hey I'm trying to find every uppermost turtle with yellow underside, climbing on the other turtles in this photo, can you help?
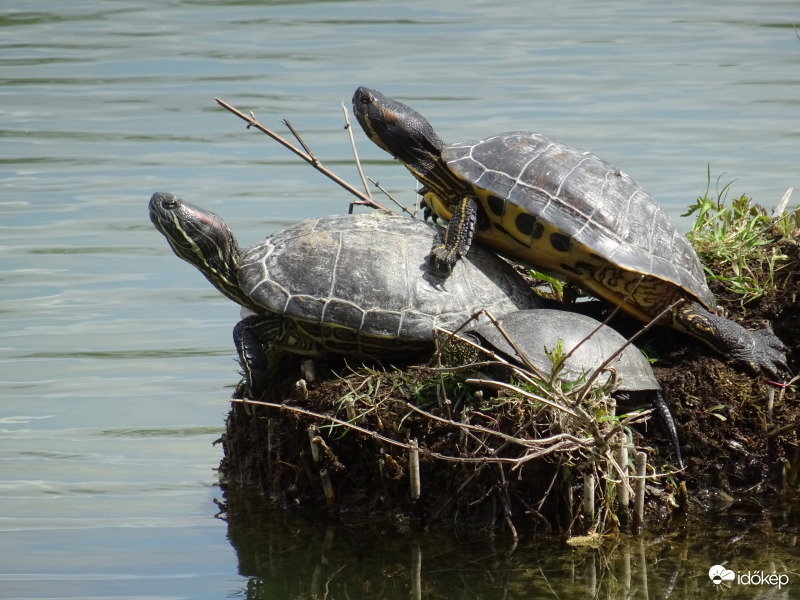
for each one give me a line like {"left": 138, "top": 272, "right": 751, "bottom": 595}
{"left": 353, "top": 87, "right": 786, "bottom": 378}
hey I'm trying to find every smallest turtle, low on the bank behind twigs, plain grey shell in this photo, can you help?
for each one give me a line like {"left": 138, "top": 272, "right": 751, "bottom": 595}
{"left": 461, "top": 308, "right": 683, "bottom": 469}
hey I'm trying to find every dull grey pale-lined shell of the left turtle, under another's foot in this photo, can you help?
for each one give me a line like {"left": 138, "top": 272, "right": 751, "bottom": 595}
{"left": 238, "top": 212, "right": 537, "bottom": 356}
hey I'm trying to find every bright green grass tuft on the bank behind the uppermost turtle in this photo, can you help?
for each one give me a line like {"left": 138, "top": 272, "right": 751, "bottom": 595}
{"left": 683, "top": 167, "right": 788, "bottom": 305}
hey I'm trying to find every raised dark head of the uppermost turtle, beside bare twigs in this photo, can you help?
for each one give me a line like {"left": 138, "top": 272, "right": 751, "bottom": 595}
{"left": 353, "top": 87, "right": 448, "bottom": 185}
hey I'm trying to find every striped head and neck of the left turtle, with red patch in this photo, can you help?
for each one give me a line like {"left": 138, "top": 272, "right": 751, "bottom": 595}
{"left": 150, "top": 192, "right": 251, "bottom": 306}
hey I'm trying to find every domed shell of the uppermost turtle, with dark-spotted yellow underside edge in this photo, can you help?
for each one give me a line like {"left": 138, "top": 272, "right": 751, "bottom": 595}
{"left": 442, "top": 131, "right": 715, "bottom": 309}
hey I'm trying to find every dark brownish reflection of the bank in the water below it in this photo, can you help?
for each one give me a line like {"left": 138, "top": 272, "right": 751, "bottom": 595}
{"left": 220, "top": 492, "right": 800, "bottom": 599}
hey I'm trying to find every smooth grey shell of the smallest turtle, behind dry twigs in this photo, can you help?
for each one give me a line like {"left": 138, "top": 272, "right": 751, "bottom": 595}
{"left": 466, "top": 308, "right": 661, "bottom": 392}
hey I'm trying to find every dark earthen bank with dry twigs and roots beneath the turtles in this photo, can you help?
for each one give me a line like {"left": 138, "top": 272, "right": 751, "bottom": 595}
{"left": 220, "top": 210, "right": 800, "bottom": 534}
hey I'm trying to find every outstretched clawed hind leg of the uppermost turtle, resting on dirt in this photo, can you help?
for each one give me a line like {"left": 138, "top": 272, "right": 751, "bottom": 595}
{"left": 672, "top": 302, "right": 787, "bottom": 378}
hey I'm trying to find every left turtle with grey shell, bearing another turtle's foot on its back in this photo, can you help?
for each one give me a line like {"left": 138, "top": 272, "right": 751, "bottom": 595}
{"left": 149, "top": 192, "right": 539, "bottom": 398}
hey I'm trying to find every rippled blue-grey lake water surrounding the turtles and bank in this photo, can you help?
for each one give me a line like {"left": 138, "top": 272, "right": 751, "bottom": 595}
{"left": 0, "top": 0, "right": 800, "bottom": 598}
